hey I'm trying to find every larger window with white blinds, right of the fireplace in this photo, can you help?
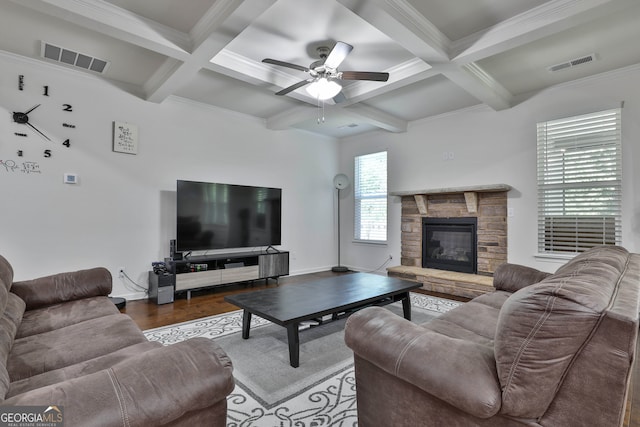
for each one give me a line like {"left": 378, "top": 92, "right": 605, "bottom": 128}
{"left": 538, "top": 109, "right": 622, "bottom": 253}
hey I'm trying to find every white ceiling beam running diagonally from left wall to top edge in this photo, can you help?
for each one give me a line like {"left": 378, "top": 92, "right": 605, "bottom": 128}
{"left": 144, "top": 0, "right": 275, "bottom": 102}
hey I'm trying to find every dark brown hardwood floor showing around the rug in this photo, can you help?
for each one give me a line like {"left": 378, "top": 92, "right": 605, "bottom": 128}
{"left": 121, "top": 271, "right": 640, "bottom": 427}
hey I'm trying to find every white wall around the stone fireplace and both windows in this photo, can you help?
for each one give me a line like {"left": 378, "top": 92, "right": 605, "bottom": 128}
{"left": 339, "top": 66, "right": 640, "bottom": 271}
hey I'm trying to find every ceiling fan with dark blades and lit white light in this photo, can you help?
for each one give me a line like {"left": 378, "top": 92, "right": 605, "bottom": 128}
{"left": 262, "top": 42, "right": 389, "bottom": 103}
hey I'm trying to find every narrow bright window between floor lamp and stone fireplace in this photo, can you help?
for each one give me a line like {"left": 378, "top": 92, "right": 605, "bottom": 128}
{"left": 354, "top": 151, "right": 387, "bottom": 242}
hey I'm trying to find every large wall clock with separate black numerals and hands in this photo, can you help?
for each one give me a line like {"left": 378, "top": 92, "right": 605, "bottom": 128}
{"left": 10, "top": 74, "right": 76, "bottom": 158}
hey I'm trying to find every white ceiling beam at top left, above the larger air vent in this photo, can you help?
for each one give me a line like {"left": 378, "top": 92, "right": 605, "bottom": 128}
{"left": 12, "top": 0, "right": 191, "bottom": 60}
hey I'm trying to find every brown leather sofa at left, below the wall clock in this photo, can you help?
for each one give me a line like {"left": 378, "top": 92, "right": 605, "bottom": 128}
{"left": 0, "top": 256, "right": 234, "bottom": 427}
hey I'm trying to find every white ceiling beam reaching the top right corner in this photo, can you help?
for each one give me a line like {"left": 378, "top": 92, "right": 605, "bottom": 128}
{"left": 451, "top": 0, "right": 637, "bottom": 64}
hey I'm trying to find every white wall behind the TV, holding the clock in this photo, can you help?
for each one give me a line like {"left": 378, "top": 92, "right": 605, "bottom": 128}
{"left": 0, "top": 56, "right": 338, "bottom": 298}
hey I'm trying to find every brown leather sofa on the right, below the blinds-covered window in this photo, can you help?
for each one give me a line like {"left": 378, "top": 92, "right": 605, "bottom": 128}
{"left": 345, "top": 246, "right": 640, "bottom": 427}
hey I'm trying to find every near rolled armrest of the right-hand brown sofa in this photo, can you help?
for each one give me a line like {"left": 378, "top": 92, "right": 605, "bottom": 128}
{"left": 345, "top": 307, "right": 501, "bottom": 418}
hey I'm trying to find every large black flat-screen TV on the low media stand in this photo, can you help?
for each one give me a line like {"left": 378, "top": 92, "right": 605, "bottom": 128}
{"left": 176, "top": 180, "right": 282, "bottom": 252}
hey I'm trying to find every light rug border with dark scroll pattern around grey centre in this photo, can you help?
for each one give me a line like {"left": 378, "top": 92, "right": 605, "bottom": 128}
{"left": 145, "top": 293, "right": 460, "bottom": 427}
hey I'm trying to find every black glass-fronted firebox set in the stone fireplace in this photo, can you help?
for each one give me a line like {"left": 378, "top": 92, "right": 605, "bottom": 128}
{"left": 422, "top": 217, "right": 478, "bottom": 274}
